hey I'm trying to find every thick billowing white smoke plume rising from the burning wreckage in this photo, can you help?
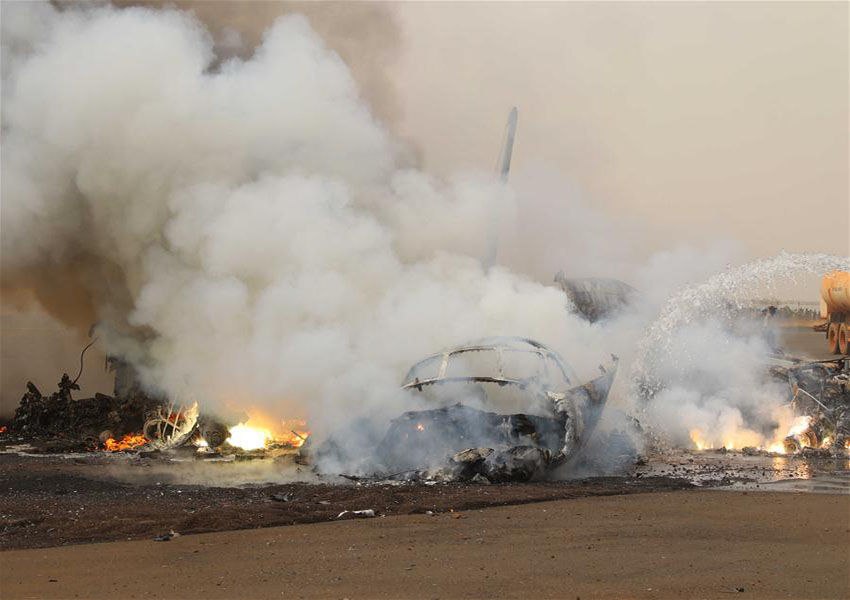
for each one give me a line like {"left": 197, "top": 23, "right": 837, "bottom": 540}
{"left": 2, "top": 4, "right": 844, "bottom": 464}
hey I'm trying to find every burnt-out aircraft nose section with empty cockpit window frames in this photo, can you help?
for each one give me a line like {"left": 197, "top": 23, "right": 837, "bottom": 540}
{"left": 305, "top": 338, "right": 616, "bottom": 481}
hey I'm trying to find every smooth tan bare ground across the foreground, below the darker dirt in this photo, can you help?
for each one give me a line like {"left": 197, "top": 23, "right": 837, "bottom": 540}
{"left": 0, "top": 491, "right": 850, "bottom": 599}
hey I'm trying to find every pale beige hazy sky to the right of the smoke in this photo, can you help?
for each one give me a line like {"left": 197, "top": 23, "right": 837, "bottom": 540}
{"left": 392, "top": 2, "right": 850, "bottom": 256}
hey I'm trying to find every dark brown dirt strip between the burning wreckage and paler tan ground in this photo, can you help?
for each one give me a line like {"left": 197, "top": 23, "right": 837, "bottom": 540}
{"left": 0, "top": 454, "right": 693, "bottom": 549}
